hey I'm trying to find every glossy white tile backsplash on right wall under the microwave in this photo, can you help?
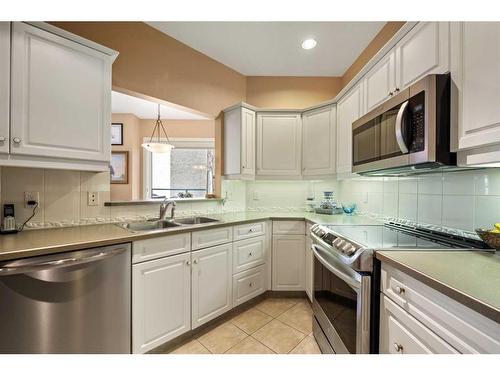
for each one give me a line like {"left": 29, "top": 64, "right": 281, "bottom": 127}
{"left": 339, "top": 168, "right": 500, "bottom": 231}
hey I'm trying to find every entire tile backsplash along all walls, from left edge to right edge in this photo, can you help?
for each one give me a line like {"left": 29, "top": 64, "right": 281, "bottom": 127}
{"left": 0, "top": 167, "right": 500, "bottom": 231}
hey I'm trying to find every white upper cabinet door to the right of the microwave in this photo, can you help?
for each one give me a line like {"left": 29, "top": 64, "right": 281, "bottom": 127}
{"left": 451, "top": 22, "right": 500, "bottom": 150}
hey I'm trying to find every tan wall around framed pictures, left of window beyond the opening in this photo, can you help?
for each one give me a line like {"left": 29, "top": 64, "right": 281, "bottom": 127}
{"left": 111, "top": 113, "right": 142, "bottom": 201}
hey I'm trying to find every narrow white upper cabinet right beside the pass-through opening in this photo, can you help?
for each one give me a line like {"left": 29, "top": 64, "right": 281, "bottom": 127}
{"left": 224, "top": 107, "right": 256, "bottom": 178}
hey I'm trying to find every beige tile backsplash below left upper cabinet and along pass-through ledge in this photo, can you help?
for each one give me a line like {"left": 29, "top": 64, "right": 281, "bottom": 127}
{"left": 0, "top": 167, "right": 222, "bottom": 228}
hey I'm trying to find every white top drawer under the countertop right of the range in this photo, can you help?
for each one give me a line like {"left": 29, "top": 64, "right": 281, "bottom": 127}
{"left": 380, "top": 263, "right": 500, "bottom": 353}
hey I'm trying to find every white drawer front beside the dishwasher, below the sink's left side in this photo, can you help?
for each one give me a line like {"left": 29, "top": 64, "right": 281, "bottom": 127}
{"left": 132, "top": 233, "right": 191, "bottom": 263}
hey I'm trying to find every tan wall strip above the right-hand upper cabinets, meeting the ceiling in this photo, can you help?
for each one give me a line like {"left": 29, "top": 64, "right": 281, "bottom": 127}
{"left": 342, "top": 21, "right": 406, "bottom": 87}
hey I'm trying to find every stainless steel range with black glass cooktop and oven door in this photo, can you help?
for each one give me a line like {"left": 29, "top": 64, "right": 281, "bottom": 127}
{"left": 311, "top": 221, "right": 491, "bottom": 354}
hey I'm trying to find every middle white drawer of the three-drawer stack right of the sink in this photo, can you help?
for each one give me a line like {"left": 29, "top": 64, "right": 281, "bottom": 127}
{"left": 233, "top": 236, "right": 266, "bottom": 274}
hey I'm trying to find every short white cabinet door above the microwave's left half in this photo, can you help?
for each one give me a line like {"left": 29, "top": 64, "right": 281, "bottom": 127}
{"left": 363, "top": 51, "right": 396, "bottom": 112}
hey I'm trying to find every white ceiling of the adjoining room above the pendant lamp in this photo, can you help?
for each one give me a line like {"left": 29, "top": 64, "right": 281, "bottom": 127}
{"left": 111, "top": 91, "right": 208, "bottom": 120}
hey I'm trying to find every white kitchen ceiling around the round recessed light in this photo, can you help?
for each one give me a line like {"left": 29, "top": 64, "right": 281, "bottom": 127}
{"left": 147, "top": 22, "right": 385, "bottom": 76}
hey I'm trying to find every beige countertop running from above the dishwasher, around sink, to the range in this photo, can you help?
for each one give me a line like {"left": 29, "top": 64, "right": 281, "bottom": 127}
{"left": 0, "top": 212, "right": 380, "bottom": 261}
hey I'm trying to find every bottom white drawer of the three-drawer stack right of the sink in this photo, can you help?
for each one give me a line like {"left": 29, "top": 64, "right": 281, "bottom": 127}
{"left": 233, "top": 266, "right": 266, "bottom": 307}
